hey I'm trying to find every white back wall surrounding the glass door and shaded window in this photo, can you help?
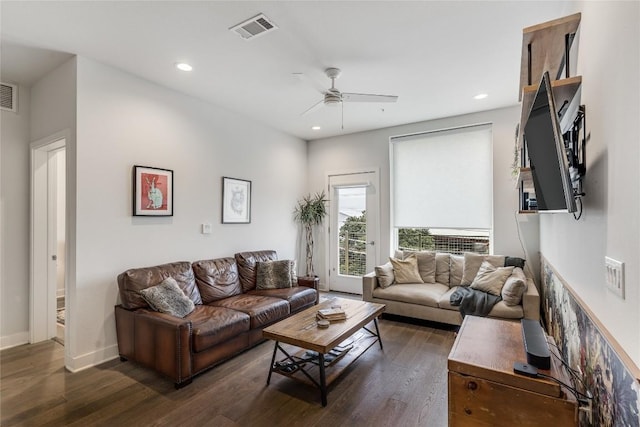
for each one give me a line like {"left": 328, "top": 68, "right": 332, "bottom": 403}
{"left": 309, "top": 106, "right": 539, "bottom": 290}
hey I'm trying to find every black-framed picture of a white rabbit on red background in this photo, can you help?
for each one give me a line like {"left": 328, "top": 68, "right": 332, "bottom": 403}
{"left": 133, "top": 165, "right": 173, "bottom": 216}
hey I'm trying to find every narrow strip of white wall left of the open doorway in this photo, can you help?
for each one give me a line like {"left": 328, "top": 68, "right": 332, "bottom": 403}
{"left": 0, "top": 86, "right": 30, "bottom": 348}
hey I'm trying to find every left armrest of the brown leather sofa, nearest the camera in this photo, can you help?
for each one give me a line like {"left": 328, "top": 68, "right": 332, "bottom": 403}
{"left": 134, "top": 309, "right": 194, "bottom": 387}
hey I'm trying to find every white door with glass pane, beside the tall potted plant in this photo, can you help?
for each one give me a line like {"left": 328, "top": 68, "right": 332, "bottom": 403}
{"left": 329, "top": 171, "right": 380, "bottom": 294}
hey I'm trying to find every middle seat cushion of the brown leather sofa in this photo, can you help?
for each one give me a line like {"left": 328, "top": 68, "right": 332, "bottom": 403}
{"left": 210, "top": 294, "right": 290, "bottom": 329}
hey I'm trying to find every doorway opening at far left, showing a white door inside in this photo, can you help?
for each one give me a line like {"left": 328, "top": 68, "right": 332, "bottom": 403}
{"left": 30, "top": 135, "right": 68, "bottom": 344}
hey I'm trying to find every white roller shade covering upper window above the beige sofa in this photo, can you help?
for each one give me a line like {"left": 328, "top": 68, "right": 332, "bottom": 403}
{"left": 390, "top": 125, "right": 493, "bottom": 229}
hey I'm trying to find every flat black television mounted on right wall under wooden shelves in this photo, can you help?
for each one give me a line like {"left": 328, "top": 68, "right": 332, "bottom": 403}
{"left": 524, "top": 72, "right": 576, "bottom": 216}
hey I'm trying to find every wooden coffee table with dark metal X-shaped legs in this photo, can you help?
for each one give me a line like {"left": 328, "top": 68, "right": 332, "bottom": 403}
{"left": 262, "top": 298, "right": 385, "bottom": 406}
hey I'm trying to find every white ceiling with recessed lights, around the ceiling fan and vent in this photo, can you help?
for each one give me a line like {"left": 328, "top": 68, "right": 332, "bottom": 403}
{"left": 0, "top": 0, "right": 573, "bottom": 140}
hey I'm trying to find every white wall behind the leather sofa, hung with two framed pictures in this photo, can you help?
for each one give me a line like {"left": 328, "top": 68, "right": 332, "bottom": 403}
{"left": 70, "top": 58, "right": 306, "bottom": 368}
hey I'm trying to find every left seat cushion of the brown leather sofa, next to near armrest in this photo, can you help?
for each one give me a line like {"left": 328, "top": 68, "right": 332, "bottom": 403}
{"left": 187, "top": 305, "right": 251, "bottom": 353}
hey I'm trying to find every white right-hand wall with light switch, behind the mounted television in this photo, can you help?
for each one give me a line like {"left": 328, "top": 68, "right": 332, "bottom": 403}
{"left": 540, "top": 1, "right": 640, "bottom": 365}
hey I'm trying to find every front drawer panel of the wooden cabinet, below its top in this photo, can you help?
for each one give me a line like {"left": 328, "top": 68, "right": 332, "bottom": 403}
{"left": 449, "top": 371, "right": 578, "bottom": 427}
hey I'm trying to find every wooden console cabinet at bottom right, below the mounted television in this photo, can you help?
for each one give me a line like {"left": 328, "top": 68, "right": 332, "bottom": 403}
{"left": 447, "top": 316, "right": 578, "bottom": 427}
